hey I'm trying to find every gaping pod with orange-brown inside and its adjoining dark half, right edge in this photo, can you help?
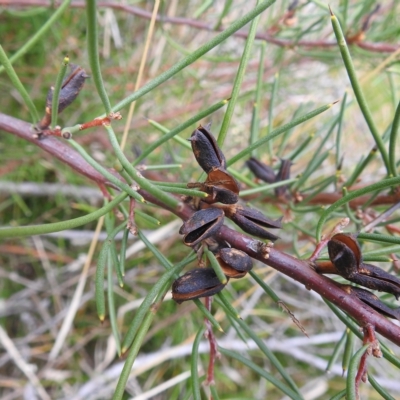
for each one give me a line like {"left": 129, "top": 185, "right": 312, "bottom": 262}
{"left": 328, "top": 233, "right": 400, "bottom": 299}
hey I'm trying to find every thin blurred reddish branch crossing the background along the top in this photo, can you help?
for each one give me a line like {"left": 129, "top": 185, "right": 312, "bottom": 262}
{"left": 0, "top": 0, "right": 399, "bottom": 53}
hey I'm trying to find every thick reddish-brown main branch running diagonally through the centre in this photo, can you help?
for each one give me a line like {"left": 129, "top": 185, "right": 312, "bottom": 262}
{"left": 0, "top": 113, "right": 400, "bottom": 346}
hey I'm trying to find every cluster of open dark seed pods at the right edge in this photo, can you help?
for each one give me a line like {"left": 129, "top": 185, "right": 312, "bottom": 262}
{"left": 322, "top": 233, "right": 400, "bottom": 320}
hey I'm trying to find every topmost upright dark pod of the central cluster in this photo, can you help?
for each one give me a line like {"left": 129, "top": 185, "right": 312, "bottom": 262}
{"left": 188, "top": 125, "right": 226, "bottom": 174}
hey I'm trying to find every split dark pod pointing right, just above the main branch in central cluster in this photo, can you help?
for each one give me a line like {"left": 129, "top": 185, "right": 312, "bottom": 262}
{"left": 225, "top": 206, "right": 282, "bottom": 242}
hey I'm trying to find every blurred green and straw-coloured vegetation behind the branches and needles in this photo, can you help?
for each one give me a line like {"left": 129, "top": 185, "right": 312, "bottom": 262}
{"left": 0, "top": 0, "right": 400, "bottom": 400}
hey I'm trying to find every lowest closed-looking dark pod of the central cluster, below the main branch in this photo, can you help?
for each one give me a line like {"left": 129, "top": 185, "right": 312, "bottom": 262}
{"left": 172, "top": 268, "right": 225, "bottom": 303}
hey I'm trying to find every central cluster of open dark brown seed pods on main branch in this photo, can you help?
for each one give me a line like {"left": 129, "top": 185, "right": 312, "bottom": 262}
{"left": 172, "top": 125, "right": 281, "bottom": 303}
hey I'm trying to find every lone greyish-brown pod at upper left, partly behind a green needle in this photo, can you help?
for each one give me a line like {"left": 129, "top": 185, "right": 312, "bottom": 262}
{"left": 38, "top": 64, "right": 89, "bottom": 129}
